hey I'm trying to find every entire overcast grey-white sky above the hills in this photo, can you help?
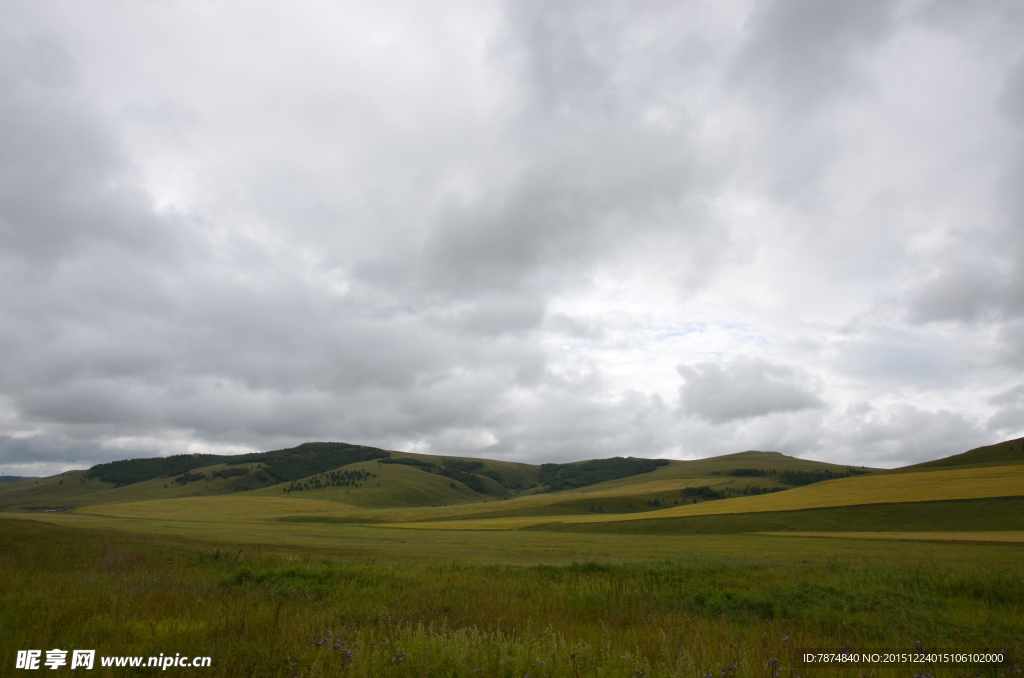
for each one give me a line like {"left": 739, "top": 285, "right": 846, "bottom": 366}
{"left": 0, "top": 0, "right": 1024, "bottom": 475}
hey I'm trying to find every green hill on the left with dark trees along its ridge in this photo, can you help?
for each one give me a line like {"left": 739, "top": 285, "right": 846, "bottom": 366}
{"left": 0, "top": 442, "right": 540, "bottom": 510}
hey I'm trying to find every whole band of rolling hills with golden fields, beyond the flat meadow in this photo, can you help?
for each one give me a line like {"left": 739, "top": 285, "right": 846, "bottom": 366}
{"left": 0, "top": 440, "right": 1024, "bottom": 535}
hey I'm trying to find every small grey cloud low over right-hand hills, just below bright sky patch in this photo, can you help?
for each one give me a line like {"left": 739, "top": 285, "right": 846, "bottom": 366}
{"left": 676, "top": 357, "right": 824, "bottom": 423}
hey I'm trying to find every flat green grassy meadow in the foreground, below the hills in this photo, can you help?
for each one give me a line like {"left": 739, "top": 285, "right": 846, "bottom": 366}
{"left": 0, "top": 519, "right": 1024, "bottom": 678}
